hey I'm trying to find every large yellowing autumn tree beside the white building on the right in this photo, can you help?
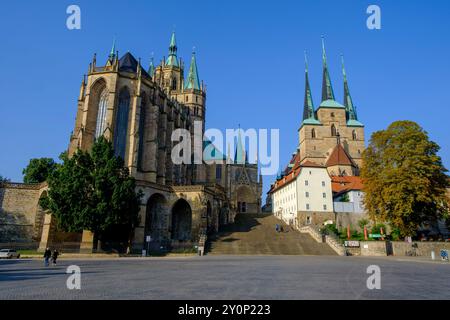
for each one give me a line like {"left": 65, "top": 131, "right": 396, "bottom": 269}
{"left": 361, "top": 121, "right": 448, "bottom": 236}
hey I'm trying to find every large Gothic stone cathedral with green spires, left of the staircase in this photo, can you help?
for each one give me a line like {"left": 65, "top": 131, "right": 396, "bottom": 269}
{"left": 2, "top": 33, "right": 262, "bottom": 251}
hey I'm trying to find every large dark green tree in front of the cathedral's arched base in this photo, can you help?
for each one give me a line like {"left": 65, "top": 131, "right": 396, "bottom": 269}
{"left": 41, "top": 137, "right": 142, "bottom": 246}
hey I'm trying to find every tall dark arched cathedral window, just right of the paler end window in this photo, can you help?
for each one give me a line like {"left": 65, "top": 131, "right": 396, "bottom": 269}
{"left": 114, "top": 88, "right": 130, "bottom": 160}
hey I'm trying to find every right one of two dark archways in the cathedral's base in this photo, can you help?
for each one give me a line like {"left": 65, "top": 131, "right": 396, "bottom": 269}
{"left": 171, "top": 199, "right": 192, "bottom": 241}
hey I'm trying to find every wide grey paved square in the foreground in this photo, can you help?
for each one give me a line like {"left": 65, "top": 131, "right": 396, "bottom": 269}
{"left": 0, "top": 255, "right": 450, "bottom": 299}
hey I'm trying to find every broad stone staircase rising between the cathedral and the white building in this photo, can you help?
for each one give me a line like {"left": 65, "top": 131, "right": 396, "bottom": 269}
{"left": 206, "top": 213, "right": 337, "bottom": 255}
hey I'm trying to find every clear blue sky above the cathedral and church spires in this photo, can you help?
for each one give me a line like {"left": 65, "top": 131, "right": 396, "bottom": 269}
{"left": 0, "top": 0, "right": 450, "bottom": 200}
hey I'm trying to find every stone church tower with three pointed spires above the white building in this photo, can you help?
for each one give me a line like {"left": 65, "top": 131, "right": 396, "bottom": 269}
{"left": 299, "top": 38, "right": 364, "bottom": 175}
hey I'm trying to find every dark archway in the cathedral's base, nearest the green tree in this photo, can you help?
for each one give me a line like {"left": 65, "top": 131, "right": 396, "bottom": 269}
{"left": 144, "top": 193, "right": 166, "bottom": 241}
